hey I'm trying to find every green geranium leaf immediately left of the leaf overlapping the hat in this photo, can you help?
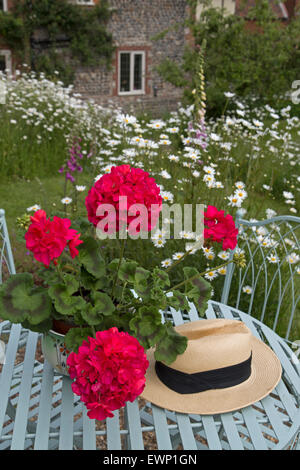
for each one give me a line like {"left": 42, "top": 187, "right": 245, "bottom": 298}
{"left": 129, "top": 307, "right": 164, "bottom": 349}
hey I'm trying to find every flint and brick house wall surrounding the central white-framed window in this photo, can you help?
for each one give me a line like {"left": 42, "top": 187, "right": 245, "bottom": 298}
{"left": 74, "top": 0, "right": 190, "bottom": 113}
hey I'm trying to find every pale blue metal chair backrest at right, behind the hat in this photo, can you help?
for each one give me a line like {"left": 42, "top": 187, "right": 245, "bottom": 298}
{"left": 221, "top": 212, "right": 300, "bottom": 340}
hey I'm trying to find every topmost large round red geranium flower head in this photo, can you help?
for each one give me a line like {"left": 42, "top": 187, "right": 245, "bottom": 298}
{"left": 85, "top": 165, "right": 162, "bottom": 233}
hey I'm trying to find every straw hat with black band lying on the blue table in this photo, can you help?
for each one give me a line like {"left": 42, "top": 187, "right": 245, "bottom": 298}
{"left": 141, "top": 319, "right": 281, "bottom": 415}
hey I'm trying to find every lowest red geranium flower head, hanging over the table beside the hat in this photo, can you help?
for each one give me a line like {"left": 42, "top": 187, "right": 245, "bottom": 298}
{"left": 67, "top": 328, "right": 149, "bottom": 420}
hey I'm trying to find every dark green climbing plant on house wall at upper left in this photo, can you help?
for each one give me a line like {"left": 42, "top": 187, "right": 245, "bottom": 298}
{"left": 0, "top": 0, "right": 114, "bottom": 82}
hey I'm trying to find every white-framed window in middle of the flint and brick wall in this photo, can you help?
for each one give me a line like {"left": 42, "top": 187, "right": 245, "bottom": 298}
{"left": 119, "top": 51, "right": 145, "bottom": 95}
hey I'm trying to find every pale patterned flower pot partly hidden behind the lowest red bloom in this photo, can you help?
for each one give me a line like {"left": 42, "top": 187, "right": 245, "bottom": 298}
{"left": 42, "top": 330, "right": 71, "bottom": 376}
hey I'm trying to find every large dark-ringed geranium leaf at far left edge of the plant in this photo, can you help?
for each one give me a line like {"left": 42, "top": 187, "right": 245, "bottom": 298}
{"left": 0, "top": 273, "right": 52, "bottom": 325}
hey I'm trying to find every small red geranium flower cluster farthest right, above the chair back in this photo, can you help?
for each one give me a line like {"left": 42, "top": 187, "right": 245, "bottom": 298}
{"left": 204, "top": 206, "right": 239, "bottom": 250}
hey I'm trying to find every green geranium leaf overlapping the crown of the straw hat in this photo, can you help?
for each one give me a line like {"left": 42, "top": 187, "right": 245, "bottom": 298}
{"left": 154, "top": 322, "right": 187, "bottom": 364}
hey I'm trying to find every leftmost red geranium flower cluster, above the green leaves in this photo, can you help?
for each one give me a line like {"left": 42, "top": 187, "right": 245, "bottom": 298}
{"left": 25, "top": 210, "right": 83, "bottom": 267}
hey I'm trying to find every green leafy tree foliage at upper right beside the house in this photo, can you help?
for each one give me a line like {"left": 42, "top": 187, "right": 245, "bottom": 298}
{"left": 159, "top": 0, "right": 300, "bottom": 114}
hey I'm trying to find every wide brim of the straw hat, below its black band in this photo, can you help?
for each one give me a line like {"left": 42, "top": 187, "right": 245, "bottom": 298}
{"left": 141, "top": 336, "right": 282, "bottom": 415}
